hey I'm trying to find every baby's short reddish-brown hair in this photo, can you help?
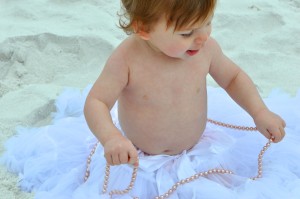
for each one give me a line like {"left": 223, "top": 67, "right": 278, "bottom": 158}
{"left": 119, "top": 0, "right": 217, "bottom": 34}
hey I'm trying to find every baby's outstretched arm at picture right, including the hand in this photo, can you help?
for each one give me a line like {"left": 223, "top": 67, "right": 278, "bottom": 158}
{"left": 209, "top": 39, "right": 285, "bottom": 142}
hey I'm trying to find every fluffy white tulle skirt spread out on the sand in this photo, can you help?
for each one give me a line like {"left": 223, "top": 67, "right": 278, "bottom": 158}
{"left": 1, "top": 87, "right": 300, "bottom": 199}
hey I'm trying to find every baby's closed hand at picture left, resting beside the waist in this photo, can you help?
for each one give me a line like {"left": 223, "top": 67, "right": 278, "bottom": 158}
{"left": 103, "top": 134, "right": 138, "bottom": 166}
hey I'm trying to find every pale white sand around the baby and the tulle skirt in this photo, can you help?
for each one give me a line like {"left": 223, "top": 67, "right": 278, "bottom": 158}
{"left": 0, "top": 0, "right": 300, "bottom": 199}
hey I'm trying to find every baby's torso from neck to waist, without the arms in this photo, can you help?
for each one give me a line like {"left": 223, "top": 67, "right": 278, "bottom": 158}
{"left": 119, "top": 38, "right": 210, "bottom": 155}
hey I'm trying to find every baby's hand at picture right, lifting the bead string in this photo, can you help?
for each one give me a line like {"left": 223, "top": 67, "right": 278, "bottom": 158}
{"left": 253, "top": 109, "right": 286, "bottom": 143}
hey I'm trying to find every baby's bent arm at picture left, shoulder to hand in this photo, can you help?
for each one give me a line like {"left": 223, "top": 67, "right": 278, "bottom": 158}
{"left": 84, "top": 49, "right": 137, "bottom": 165}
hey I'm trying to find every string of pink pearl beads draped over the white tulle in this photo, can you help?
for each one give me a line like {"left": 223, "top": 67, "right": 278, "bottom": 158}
{"left": 84, "top": 119, "right": 273, "bottom": 199}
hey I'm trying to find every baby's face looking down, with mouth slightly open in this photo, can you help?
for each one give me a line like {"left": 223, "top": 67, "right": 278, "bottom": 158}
{"left": 148, "top": 16, "right": 213, "bottom": 59}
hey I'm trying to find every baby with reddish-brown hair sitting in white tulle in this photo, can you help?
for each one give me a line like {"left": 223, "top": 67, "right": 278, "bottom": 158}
{"left": 84, "top": 0, "right": 285, "bottom": 165}
